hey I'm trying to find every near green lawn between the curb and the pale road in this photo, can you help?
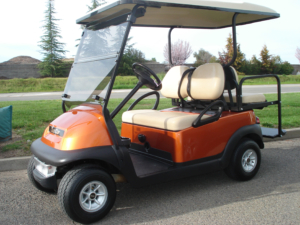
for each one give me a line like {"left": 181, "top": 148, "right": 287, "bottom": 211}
{"left": 0, "top": 93, "right": 300, "bottom": 155}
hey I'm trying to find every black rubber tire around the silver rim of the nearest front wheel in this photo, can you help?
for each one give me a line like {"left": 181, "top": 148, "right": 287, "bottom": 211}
{"left": 57, "top": 165, "right": 116, "bottom": 224}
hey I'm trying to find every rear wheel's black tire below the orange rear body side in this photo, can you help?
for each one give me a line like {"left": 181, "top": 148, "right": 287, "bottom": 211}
{"left": 225, "top": 139, "right": 261, "bottom": 181}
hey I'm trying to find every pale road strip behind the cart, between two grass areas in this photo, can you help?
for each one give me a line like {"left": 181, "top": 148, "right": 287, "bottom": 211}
{"left": 0, "top": 84, "right": 300, "bottom": 101}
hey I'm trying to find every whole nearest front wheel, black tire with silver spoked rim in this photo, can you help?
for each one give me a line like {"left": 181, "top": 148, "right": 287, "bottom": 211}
{"left": 58, "top": 164, "right": 116, "bottom": 224}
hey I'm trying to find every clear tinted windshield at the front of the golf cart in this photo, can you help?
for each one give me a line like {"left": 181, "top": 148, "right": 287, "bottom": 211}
{"left": 63, "top": 22, "right": 128, "bottom": 107}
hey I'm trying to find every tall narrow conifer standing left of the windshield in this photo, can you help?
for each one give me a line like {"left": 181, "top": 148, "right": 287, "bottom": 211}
{"left": 38, "top": 0, "right": 66, "bottom": 77}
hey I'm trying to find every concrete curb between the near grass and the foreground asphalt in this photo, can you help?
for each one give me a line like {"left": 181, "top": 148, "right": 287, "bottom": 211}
{"left": 0, "top": 128, "right": 300, "bottom": 172}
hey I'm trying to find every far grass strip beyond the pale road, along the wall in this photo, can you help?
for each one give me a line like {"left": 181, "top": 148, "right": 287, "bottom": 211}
{"left": 0, "top": 74, "right": 300, "bottom": 93}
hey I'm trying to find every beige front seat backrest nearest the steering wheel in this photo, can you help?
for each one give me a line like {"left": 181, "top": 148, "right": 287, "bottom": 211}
{"left": 160, "top": 66, "right": 189, "bottom": 99}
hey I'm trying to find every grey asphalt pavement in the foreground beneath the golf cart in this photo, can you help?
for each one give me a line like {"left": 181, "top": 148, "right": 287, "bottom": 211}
{"left": 0, "top": 139, "right": 300, "bottom": 225}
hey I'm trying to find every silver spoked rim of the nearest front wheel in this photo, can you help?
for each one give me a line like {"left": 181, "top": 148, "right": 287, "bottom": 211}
{"left": 79, "top": 181, "right": 108, "bottom": 212}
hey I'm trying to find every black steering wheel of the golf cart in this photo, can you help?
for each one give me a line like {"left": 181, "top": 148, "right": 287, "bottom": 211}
{"left": 132, "top": 63, "right": 162, "bottom": 91}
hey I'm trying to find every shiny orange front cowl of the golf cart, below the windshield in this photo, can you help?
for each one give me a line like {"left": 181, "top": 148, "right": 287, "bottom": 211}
{"left": 42, "top": 104, "right": 112, "bottom": 151}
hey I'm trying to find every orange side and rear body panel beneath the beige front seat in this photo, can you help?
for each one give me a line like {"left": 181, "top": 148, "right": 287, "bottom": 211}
{"left": 122, "top": 111, "right": 255, "bottom": 163}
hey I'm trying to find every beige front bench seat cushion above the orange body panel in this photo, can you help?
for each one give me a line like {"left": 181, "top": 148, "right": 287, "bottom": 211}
{"left": 122, "top": 110, "right": 210, "bottom": 131}
